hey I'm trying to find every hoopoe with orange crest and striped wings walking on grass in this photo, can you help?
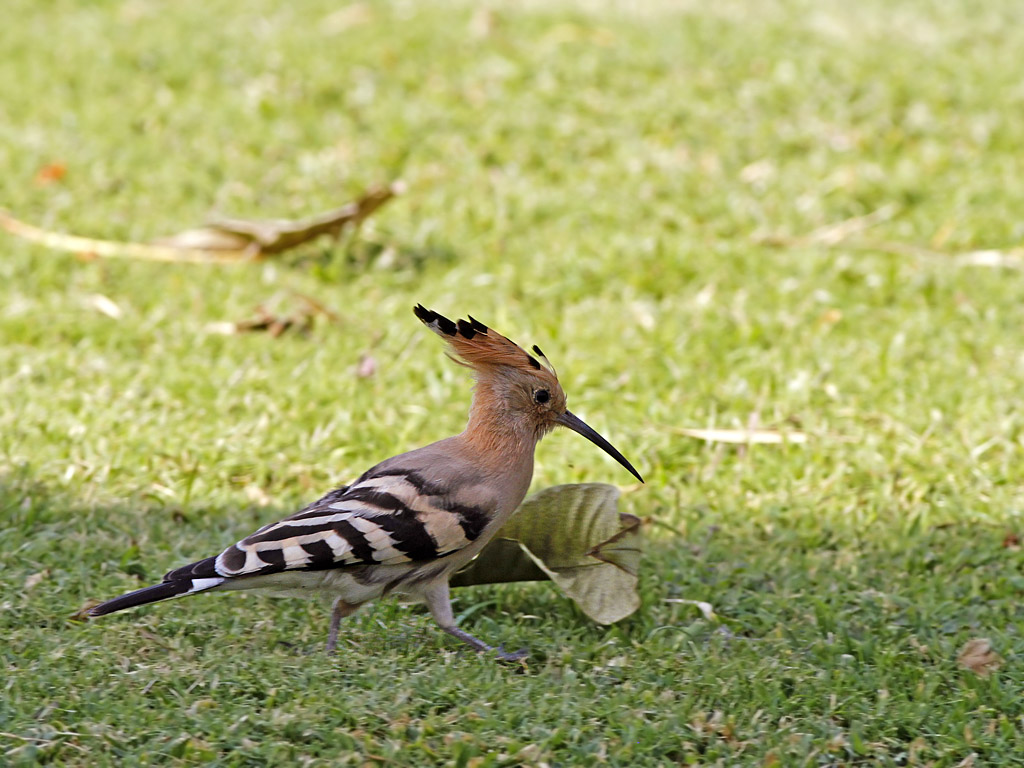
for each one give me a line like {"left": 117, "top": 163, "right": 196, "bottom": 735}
{"left": 88, "top": 304, "right": 643, "bottom": 660}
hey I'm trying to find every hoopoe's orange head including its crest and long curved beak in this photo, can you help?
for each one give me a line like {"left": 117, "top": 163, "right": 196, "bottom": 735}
{"left": 414, "top": 304, "right": 643, "bottom": 482}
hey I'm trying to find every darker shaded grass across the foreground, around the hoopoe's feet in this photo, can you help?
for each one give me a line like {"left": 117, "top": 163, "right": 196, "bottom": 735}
{"left": 0, "top": 474, "right": 1024, "bottom": 765}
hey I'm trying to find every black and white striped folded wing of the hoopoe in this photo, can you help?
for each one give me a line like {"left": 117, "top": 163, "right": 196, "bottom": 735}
{"left": 207, "top": 468, "right": 489, "bottom": 579}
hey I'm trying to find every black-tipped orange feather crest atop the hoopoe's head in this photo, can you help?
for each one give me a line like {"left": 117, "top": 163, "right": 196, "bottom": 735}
{"left": 413, "top": 304, "right": 557, "bottom": 379}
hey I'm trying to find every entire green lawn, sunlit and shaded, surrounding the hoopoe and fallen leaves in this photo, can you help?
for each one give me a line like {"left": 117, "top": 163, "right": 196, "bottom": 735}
{"left": 0, "top": 0, "right": 1024, "bottom": 766}
